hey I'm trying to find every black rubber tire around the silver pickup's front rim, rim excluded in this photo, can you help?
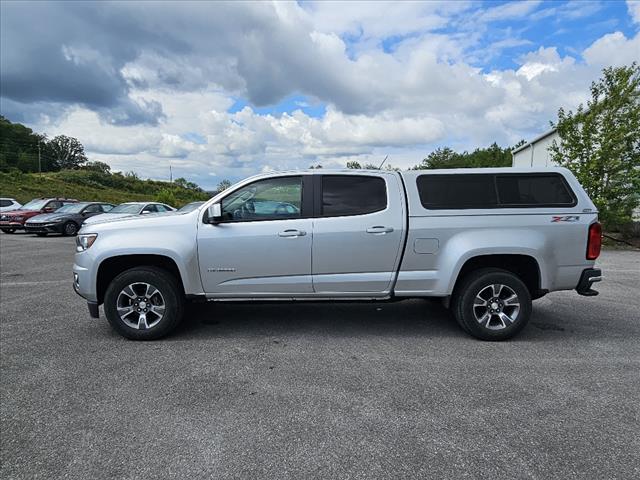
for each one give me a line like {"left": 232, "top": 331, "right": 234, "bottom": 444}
{"left": 104, "top": 267, "right": 184, "bottom": 340}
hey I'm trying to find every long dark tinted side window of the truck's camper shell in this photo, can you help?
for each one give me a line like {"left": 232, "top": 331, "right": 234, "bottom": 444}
{"left": 416, "top": 173, "right": 577, "bottom": 210}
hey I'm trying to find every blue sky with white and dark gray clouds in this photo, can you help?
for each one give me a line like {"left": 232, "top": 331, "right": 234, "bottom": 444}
{"left": 0, "top": 0, "right": 640, "bottom": 188}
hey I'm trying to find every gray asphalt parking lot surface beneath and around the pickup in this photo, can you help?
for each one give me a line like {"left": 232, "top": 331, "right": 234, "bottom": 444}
{"left": 0, "top": 235, "right": 640, "bottom": 479}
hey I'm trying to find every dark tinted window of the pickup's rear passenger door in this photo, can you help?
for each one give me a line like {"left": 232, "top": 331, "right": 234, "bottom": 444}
{"left": 320, "top": 175, "right": 387, "bottom": 217}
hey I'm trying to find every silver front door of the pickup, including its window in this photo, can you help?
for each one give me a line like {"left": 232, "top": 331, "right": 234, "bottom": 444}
{"left": 198, "top": 175, "right": 313, "bottom": 297}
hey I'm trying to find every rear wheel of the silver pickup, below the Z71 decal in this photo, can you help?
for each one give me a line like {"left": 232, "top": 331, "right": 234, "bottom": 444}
{"left": 452, "top": 268, "right": 531, "bottom": 341}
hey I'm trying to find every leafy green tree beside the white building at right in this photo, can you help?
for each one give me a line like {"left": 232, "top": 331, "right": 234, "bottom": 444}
{"left": 550, "top": 62, "right": 640, "bottom": 227}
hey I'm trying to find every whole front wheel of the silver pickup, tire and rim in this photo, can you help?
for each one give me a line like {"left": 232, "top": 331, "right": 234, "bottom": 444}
{"left": 104, "top": 267, "right": 184, "bottom": 340}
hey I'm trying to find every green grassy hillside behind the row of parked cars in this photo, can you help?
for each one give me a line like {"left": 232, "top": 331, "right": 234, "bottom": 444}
{"left": 0, "top": 170, "right": 209, "bottom": 208}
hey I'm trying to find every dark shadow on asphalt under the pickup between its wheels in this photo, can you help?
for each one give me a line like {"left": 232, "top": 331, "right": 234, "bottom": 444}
{"left": 168, "top": 300, "right": 466, "bottom": 340}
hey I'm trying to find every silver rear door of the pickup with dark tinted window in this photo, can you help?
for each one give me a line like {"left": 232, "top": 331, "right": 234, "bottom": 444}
{"left": 312, "top": 172, "right": 406, "bottom": 296}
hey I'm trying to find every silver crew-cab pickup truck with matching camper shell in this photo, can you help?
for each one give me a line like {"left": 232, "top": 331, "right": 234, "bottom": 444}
{"left": 73, "top": 168, "right": 601, "bottom": 340}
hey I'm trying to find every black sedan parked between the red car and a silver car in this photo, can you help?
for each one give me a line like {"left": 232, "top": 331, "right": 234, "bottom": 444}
{"left": 25, "top": 202, "right": 115, "bottom": 237}
